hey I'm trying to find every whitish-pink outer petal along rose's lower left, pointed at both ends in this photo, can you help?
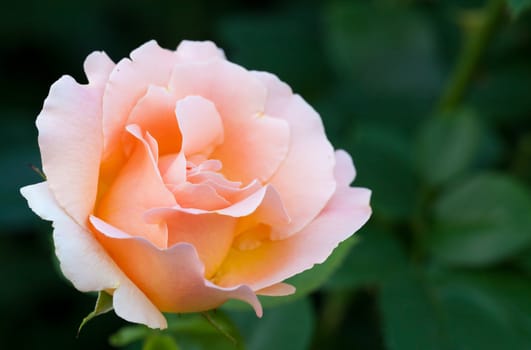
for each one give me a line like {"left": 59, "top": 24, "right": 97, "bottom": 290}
{"left": 21, "top": 182, "right": 167, "bottom": 328}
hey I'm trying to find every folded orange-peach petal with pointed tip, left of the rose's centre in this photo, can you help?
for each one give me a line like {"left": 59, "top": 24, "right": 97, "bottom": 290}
{"left": 95, "top": 125, "right": 175, "bottom": 248}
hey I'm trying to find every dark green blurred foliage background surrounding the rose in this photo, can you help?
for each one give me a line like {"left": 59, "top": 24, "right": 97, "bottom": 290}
{"left": 0, "top": 0, "right": 531, "bottom": 350}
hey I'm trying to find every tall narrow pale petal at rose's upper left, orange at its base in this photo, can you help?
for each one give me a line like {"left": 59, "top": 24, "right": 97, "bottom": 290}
{"left": 103, "top": 40, "right": 176, "bottom": 158}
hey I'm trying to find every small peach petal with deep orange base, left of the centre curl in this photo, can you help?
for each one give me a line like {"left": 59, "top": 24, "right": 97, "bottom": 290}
{"left": 127, "top": 85, "right": 182, "bottom": 155}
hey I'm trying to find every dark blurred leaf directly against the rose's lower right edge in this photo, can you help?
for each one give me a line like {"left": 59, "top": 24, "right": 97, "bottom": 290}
{"left": 326, "top": 227, "right": 406, "bottom": 289}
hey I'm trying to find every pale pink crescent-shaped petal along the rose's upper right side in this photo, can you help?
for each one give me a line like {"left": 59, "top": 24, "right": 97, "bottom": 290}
{"left": 254, "top": 73, "right": 336, "bottom": 238}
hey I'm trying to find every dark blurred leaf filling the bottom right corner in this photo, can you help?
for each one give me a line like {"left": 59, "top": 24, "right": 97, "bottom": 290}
{"left": 432, "top": 271, "right": 531, "bottom": 350}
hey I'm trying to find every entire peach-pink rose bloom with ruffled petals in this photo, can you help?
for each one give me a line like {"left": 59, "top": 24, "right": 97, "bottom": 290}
{"left": 21, "top": 41, "right": 371, "bottom": 328}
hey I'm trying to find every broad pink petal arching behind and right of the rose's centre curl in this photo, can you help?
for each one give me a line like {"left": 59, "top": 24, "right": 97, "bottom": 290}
{"left": 170, "top": 60, "right": 290, "bottom": 183}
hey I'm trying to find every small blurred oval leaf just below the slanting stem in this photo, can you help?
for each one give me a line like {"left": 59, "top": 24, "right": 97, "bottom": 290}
{"left": 417, "top": 110, "right": 482, "bottom": 185}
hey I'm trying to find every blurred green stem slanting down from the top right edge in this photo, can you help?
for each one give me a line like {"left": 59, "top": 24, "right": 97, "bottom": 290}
{"left": 437, "top": 0, "right": 505, "bottom": 112}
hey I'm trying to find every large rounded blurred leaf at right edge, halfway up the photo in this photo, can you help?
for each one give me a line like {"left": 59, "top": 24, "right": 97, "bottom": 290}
{"left": 427, "top": 173, "right": 531, "bottom": 266}
